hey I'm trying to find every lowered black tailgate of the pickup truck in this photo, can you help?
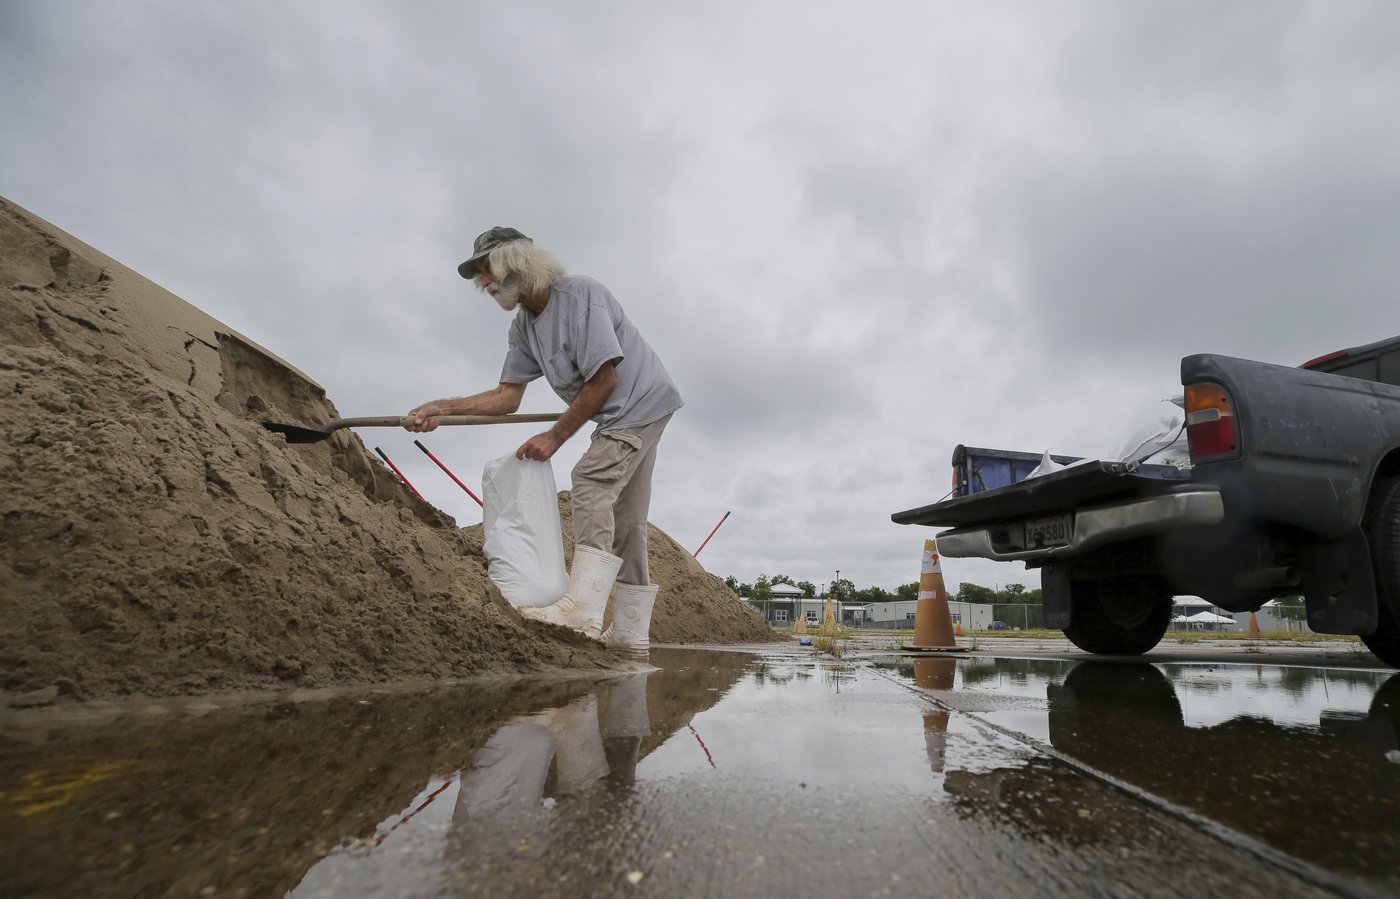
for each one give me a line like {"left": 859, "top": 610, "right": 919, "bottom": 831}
{"left": 890, "top": 462, "right": 1193, "bottom": 528}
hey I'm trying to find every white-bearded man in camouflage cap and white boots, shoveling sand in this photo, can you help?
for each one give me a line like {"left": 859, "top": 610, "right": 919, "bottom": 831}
{"left": 409, "top": 227, "right": 682, "bottom": 653}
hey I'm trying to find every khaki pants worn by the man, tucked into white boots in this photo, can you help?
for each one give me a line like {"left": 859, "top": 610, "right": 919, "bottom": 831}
{"left": 571, "top": 414, "right": 671, "bottom": 587}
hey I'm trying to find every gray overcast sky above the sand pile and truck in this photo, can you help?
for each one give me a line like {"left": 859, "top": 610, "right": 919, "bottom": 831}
{"left": 0, "top": 0, "right": 1400, "bottom": 590}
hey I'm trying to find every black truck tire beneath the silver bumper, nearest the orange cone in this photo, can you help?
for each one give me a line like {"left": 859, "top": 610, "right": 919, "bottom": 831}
{"left": 1064, "top": 577, "right": 1172, "bottom": 655}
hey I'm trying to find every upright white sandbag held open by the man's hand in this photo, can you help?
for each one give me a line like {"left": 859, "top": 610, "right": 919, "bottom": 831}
{"left": 482, "top": 452, "right": 568, "bottom": 608}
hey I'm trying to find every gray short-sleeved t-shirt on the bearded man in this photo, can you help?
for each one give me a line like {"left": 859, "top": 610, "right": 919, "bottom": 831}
{"left": 501, "top": 274, "right": 683, "bottom": 431}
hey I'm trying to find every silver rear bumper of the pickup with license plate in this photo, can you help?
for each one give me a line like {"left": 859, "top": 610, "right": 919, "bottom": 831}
{"left": 937, "top": 490, "right": 1225, "bottom": 562}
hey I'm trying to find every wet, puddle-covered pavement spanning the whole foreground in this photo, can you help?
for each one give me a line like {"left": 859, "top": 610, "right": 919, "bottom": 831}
{"left": 0, "top": 646, "right": 1400, "bottom": 898}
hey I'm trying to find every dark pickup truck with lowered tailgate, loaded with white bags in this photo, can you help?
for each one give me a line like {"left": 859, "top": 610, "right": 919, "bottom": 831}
{"left": 892, "top": 337, "right": 1400, "bottom": 667}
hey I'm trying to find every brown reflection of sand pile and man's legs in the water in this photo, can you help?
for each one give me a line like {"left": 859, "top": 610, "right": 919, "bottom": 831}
{"left": 0, "top": 650, "right": 750, "bottom": 896}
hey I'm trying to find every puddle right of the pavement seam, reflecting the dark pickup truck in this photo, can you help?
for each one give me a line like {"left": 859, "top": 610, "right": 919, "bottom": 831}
{"left": 879, "top": 649, "right": 1400, "bottom": 891}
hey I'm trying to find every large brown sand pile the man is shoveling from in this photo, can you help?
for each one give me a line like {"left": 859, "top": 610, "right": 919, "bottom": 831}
{"left": 0, "top": 199, "right": 773, "bottom": 703}
